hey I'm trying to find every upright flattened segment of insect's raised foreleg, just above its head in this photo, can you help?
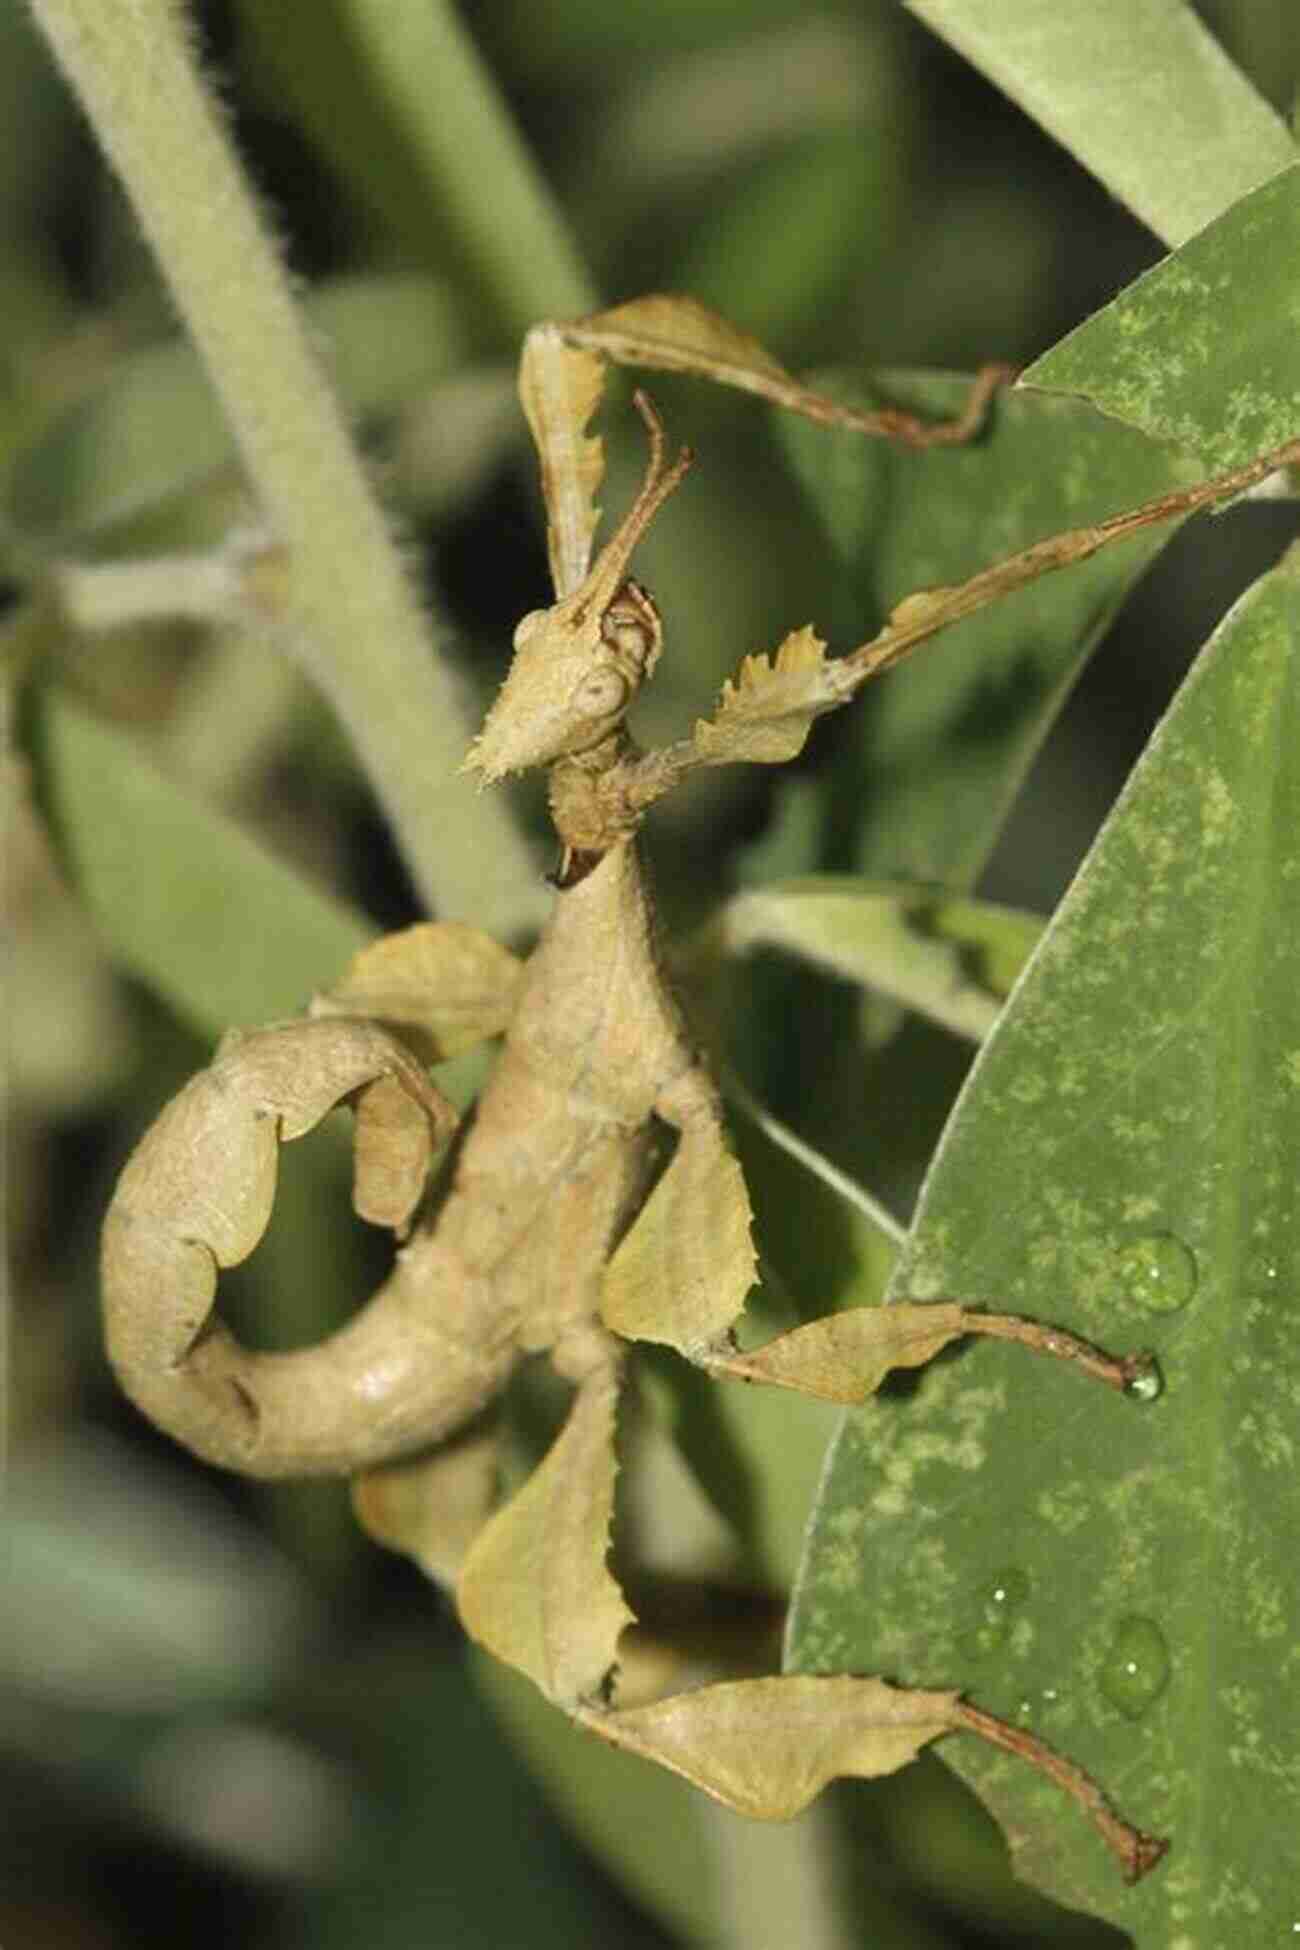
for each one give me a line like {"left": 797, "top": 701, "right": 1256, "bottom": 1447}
{"left": 518, "top": 326, "right": 604, "bottom": 597}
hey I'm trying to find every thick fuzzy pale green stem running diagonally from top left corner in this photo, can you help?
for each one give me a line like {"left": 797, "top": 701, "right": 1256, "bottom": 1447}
{"left": 33, "top": 0, "right": 540, "bottom": 928}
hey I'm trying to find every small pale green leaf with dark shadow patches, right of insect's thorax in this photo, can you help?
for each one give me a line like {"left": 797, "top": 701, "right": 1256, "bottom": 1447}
{"left": 715, "top": 874, "right": 1043, "bottom": 1043}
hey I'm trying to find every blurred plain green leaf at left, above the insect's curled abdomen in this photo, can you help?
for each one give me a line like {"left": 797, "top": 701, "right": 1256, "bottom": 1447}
{"left": 33, "top": 690, "right": 372, "bottom": 1035}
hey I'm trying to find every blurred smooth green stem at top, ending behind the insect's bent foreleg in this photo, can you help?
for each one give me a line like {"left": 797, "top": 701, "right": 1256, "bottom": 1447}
{"left": 341, "top": 0, "right": 600, "bottom": 337}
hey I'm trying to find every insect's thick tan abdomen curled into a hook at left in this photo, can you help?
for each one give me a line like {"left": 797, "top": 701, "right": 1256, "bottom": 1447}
{"left": 101, "top": 1020, "right": 461, "bottom": 1474}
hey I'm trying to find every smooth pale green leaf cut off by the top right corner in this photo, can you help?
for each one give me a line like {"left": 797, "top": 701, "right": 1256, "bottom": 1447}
{"left": 906, "top": 0, "right": 1296, "bottom": 244}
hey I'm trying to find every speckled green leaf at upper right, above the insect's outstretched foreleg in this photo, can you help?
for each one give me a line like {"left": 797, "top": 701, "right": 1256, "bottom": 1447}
{"left": 1021, "top": 162, "right": 1300, "bottom": 472}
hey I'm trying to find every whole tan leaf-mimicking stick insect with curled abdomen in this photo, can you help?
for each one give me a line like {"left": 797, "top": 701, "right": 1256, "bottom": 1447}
{"left": 103, "top": 298, "right": 1300, "bottom": 1880}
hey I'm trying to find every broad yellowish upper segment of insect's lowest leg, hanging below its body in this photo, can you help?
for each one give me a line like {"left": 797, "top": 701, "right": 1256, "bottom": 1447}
{"left": 456, "top": 1363, "right": 631, "bottom": 1708}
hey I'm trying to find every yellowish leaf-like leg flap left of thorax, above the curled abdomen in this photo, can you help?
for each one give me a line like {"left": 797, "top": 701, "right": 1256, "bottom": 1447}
{"left": 312, "top": 920, "right": 524, "bottom": 1063}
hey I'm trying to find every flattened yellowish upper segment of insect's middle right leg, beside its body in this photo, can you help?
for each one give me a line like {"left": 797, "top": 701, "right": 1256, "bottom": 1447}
{"left": 600, "top": 1117, "right": 756, "bottom": 1355}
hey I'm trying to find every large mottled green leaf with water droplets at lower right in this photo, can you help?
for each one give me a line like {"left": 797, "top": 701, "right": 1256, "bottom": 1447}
{"left": 789, "top": 550, "right": 1300, "bottom": 1950}
